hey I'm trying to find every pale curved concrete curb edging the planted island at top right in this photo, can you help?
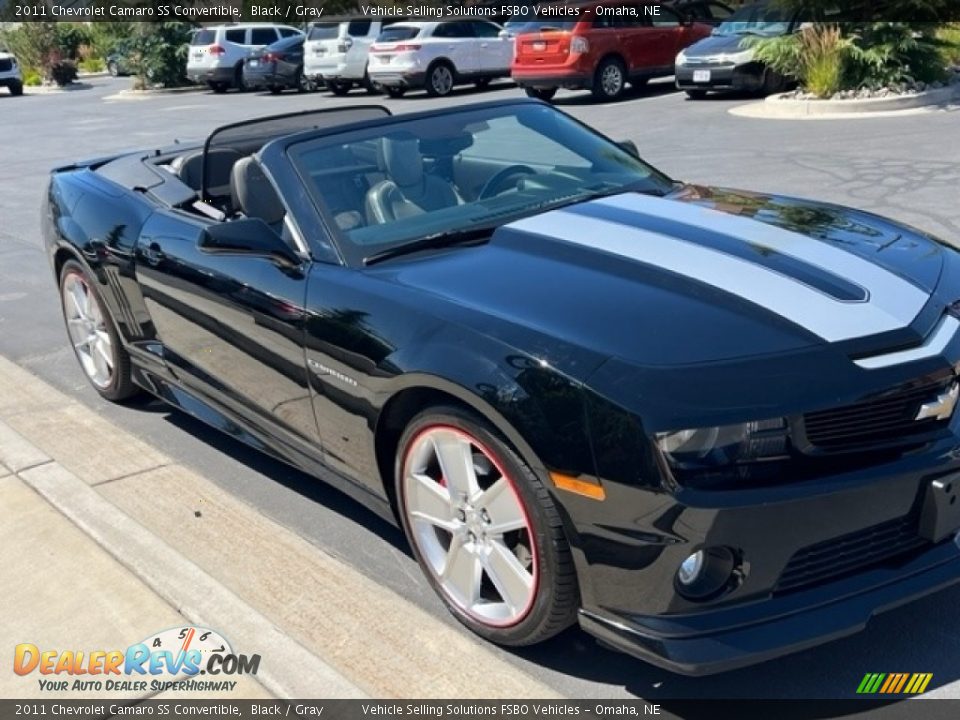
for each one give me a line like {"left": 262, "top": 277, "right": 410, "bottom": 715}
{"left": 728, "top": 84, "right": 960, "bottom": 120}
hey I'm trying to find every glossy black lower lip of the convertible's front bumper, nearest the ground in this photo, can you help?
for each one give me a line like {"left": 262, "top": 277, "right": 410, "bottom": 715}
{"left": 579, "top": 536, "right": 960, "bottom": 675}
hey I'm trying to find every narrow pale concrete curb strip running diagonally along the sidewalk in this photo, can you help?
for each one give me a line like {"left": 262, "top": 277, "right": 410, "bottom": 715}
{"left": 0, "top": 421, "right": 367, "bottom": 698}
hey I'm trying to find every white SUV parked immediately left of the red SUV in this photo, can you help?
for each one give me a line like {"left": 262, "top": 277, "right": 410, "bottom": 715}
{"left": 367, "top": 20, "right": 513, "bottom": 97}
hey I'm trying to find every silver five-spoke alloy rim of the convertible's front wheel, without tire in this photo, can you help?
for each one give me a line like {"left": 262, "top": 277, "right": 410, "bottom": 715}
{"left": 402, "top": 425, "right": 538, "bottom": 627}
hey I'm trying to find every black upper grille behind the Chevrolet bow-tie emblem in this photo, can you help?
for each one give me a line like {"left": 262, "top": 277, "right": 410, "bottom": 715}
{"left": 803, "top": 376, "right": 953, "bottom": 452}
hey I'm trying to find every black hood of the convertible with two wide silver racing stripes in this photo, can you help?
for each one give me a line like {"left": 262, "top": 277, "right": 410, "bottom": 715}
{"left": 384, "top": 186, "right": 949, "bottom": 374}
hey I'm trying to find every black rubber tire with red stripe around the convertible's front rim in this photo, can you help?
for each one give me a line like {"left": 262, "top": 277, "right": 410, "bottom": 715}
{"left": 394, "top": 406, "right": 580, "bottom": 646}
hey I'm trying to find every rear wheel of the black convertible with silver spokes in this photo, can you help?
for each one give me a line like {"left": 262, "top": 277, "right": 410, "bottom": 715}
{"left": 60, "top": 260, "right": 139, "bottom": 401}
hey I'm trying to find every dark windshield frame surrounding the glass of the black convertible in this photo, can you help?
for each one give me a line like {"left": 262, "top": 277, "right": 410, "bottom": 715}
{"left": 278, "top": 98, "right": 676, "bottom": 268}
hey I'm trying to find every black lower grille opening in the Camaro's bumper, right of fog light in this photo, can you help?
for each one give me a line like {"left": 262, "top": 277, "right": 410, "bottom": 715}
{"left": 776, "top": 515, "right": 927, "bottom": 592}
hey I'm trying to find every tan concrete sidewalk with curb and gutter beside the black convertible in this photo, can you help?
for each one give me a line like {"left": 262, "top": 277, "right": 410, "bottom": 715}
{"left": 0, "top": 358, "right": 556, "bottom": 699}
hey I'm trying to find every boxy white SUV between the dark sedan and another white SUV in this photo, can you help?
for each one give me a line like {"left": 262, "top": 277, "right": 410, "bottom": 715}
{"left": 303, "top": 18, "right": 396, "bottom": 95}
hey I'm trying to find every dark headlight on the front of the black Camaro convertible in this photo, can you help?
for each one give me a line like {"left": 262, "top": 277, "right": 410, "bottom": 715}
{"left": 654, "top": 418, "right": 787, "bottom": 470}
